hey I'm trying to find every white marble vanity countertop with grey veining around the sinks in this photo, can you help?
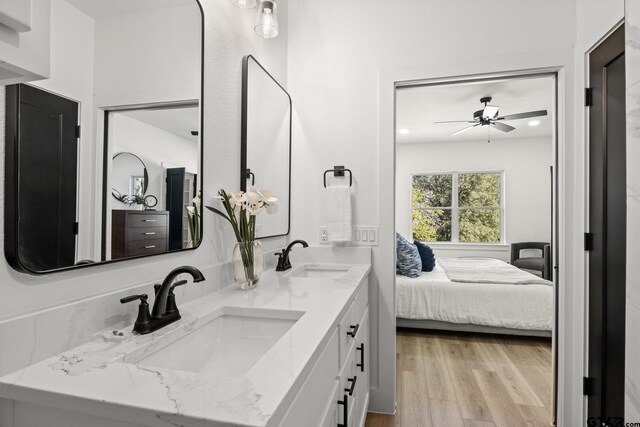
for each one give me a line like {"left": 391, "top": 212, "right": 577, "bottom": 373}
{"left": 0, "top": 264, "right": 371, "bottom": 426}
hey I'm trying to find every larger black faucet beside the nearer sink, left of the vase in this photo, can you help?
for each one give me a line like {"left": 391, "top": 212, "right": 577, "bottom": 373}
{"left": 120, "top": 265, "right": 204, "bottom": 334}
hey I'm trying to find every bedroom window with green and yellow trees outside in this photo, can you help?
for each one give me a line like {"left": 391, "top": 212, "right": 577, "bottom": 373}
{"left": 411, "top": 172, "right": 504, "bottom": 243}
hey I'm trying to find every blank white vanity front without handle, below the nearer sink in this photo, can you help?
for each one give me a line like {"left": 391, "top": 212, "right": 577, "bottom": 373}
{"left": 280, "top": 330, "right": 339, "bottom": 427}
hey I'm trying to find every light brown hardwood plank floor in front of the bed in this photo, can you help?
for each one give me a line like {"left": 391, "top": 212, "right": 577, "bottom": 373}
{"left": 365, "top": 329, "right": 552, "bottom": 427}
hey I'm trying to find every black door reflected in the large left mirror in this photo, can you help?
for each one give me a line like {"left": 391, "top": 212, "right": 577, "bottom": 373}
{"left": 6, "top": 84, "right": 78, "bottom": 272}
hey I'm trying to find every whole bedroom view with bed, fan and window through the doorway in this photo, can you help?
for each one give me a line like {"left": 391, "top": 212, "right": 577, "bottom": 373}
{"left": 388, "top": 75, "right": 555, "bottom": 425}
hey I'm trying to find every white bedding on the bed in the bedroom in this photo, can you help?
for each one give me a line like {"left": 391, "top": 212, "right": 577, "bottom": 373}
{"left": 396, "top": 263, "right": 553, "bottom": 331}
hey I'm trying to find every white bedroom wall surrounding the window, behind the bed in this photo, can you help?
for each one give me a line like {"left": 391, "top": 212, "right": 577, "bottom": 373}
{"left": 396, "top": 136, "right": 553, "bottom": 261}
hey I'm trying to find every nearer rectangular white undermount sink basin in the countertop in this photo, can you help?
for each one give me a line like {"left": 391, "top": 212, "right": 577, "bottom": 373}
{"left": 130, "top": 307, "right": 304, "bottom": 377}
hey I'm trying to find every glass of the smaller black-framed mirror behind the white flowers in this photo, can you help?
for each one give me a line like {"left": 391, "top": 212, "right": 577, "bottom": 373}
{"left": 240, "top": 55, "right": 291, "bottom": 238}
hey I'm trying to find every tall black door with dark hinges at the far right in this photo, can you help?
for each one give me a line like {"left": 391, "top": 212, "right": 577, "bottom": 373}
{"left": 588, "top": 27, "right": 627, "bottom": 426}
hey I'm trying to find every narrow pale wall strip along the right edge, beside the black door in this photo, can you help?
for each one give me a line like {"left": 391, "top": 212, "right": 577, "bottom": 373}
{"left": 624, "top": 0, "right": 640, "bottom": 421}
